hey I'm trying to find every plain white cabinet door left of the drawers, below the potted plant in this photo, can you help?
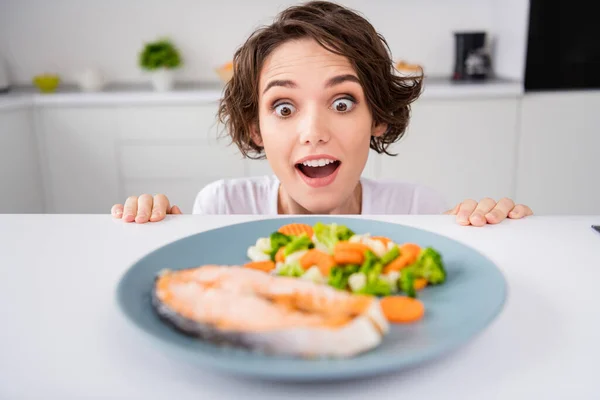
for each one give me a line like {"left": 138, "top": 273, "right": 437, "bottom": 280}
{"left": 37, "top": 107, "right": 123, "bottom": 214}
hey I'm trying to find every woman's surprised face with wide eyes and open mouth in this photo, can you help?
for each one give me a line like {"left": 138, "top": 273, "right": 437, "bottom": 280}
{"left": 254, "top": 39, "right": 386, "bottom": 214}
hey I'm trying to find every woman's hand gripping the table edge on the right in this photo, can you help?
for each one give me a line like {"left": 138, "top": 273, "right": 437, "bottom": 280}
{"left": 444, "top": 198, "right": 533, "bottom": 226}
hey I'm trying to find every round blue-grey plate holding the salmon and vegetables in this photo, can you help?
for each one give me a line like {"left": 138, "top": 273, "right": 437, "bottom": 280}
{"left": 117, "top": 216, "right": 506, "bottom": 381}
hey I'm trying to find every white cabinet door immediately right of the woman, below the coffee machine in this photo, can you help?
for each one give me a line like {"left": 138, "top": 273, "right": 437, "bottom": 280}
{"left": 379, "top": 98, "right": 519, "bottom": 206}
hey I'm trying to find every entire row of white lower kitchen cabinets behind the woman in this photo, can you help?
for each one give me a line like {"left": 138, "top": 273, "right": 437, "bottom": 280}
{"left": 19, "top": 92, "right": 600, "bottom": 214}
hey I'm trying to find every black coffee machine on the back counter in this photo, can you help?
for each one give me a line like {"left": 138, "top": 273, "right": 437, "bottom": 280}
{"left": 452, "top": 32, "right": 491, "bottom": 81}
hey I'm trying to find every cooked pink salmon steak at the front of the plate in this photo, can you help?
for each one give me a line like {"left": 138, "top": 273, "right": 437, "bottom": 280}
{"left": 152, "top": 265, "right": 389, "bottom": 357}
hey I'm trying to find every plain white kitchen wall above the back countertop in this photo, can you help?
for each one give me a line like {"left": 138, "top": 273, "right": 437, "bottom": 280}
{"left": 0, "top": 0, "right": 527, "bottom": 83}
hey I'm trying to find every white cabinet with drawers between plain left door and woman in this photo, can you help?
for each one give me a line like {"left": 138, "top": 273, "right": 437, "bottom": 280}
{"left": 116, "top": 103, "right": 247, "bottom": 213}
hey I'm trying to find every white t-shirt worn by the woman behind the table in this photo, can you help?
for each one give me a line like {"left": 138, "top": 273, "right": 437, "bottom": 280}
{"left": 193, "top": 175, "right": 448, "bottom": 215}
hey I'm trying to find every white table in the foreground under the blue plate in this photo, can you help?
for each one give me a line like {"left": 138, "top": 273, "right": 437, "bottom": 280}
{"left": 0, "top": 215, "right": 600, "bottom": 400}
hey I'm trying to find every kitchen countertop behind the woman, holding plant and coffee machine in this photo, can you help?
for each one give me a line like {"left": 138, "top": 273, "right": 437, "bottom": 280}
{"left": 0, "top": 77, "right": 523, "bottom": 110}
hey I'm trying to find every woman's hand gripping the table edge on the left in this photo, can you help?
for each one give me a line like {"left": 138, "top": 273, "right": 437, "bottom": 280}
{"left": 111, "top": 194, "right": 182, "bottom": 224}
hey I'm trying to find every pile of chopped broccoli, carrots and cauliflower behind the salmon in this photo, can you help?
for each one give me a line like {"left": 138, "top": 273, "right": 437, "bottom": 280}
{"left": 246, "top": 222, "right": 446, "bottom": 308}
